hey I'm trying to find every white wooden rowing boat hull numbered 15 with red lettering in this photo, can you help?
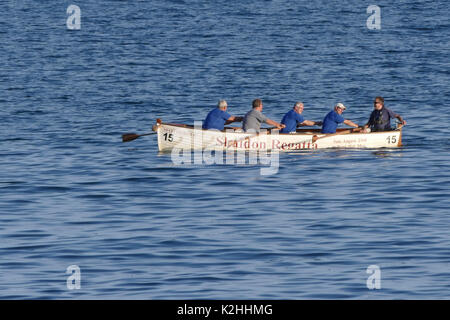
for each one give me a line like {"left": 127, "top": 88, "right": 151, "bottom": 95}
{"left": 153, "top": 119, "right": 402, "bottom": 152}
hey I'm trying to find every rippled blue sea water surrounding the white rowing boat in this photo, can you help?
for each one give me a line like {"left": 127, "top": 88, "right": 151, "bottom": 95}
{"left": 0, "top": 0, "right": 450, "bottom": 299}
